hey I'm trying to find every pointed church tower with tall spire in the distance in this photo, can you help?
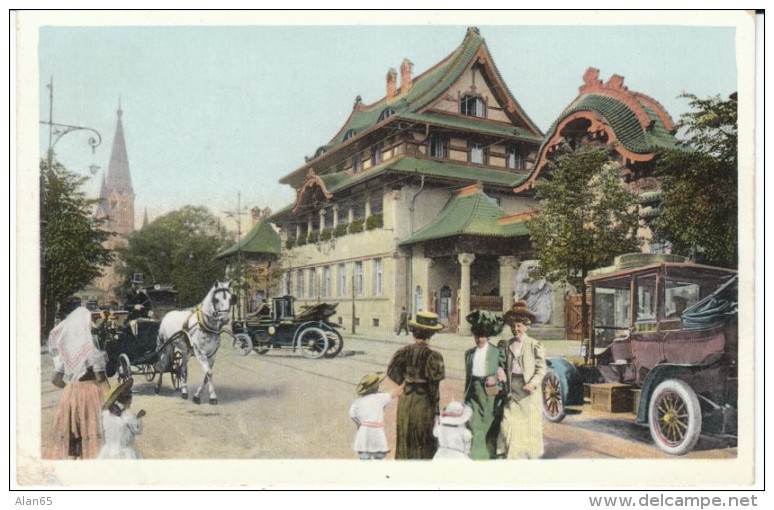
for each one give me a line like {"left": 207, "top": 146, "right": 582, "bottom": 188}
{"left": 94, "top": 100, "right": 135, "bottom": 302}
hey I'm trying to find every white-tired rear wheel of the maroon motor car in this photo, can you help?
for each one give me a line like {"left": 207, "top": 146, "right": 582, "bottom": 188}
{"left": 648, "top": 379, "right": 701, "bottom": 455}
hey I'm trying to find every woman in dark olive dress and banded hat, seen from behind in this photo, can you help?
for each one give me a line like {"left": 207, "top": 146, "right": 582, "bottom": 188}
{"left": 387, "top": 312, "right": 446, "bottom": 459}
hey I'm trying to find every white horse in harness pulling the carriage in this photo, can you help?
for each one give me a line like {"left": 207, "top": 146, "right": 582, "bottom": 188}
{"left": 156, "top": 282, "right": 236, "bottom": 404}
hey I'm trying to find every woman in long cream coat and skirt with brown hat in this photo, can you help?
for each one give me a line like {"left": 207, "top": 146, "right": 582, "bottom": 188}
{"left": 497, "top": 301, "right": 546, "bottom": 459}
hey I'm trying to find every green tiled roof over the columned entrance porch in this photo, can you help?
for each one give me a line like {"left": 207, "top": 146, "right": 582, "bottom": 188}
{"left": 400, "top": 189, "right": 529, "bottom": 245}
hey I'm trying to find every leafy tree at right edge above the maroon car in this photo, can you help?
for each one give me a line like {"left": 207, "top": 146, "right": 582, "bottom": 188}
{"left": 653, "top": 94, "right": 738, "bottom": 268}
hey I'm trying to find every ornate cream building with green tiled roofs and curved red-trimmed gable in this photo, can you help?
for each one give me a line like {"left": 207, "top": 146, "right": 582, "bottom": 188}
{"left": 271, "top": 28, "right": 674, "bottom": 338}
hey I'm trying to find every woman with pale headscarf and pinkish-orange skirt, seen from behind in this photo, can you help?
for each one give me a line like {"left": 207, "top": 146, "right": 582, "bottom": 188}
{"left": 43, "top": 307, "right": 107, "bottom": 459}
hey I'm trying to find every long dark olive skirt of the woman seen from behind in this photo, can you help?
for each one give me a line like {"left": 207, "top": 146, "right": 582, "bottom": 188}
{"left": 395, "top": 392, "right": 438, "bottom": 459}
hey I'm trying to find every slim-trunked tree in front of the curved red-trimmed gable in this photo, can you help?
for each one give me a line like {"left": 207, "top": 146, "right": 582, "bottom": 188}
{"left": 528, "top": 146, "right": 641, "bottom": 346}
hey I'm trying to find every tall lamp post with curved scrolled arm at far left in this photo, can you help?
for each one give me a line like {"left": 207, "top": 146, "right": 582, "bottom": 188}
{"left": 40, "top": 77, "right": 102, "bottom": 340}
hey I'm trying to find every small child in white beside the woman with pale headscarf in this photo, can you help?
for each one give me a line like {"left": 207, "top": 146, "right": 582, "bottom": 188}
{"left": 99, "top": 377, "right": 145, "bottom": 459}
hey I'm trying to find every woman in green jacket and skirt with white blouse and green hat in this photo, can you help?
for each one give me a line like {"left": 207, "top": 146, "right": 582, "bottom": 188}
{"left": 465, "top": 310, "right": 507, "bottom": 460}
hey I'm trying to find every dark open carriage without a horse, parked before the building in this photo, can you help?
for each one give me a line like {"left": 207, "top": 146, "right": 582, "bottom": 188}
{"left": 232, "top": 296, "right": 344, "bottom": 358}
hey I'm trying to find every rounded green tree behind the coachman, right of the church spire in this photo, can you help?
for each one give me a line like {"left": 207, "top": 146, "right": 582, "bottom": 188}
{"left": 121, "top": 206, "right": 234, "bottom": 306}
